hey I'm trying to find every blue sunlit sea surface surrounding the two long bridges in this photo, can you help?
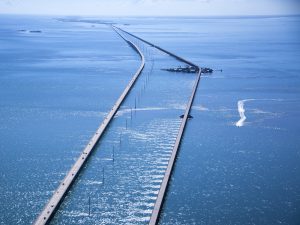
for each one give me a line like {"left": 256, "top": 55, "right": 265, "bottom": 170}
{"left": 0, "top": 15, "right": 300, "bottom": 225}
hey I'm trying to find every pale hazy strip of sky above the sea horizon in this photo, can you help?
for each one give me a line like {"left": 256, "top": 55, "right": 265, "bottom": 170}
{"left": 0, "top": 0, "right": 300, "bottom": 16}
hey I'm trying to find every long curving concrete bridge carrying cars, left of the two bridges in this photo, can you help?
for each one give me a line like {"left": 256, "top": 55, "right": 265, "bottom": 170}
{"left": 34, "top": 27, "right": 145, "bottom": 225}
